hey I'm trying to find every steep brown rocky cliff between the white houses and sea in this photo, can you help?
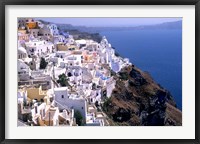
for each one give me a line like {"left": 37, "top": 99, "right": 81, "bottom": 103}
{"left": 102, "top": 66, "right": 182, "bottom": 126}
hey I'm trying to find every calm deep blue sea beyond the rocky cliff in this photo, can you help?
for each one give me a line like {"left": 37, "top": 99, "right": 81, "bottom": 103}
{"left": 101, "top": 29, "right": 182, "bottom": 110}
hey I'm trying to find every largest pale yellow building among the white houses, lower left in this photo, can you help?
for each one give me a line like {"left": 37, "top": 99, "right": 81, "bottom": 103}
{"left": 27, "top": 86, "right": 47, "bottom": 100}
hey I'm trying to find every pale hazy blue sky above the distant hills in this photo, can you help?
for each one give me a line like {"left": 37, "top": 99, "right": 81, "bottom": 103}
{"left": 36, "top": 18, "right": 182, "bottom": 26}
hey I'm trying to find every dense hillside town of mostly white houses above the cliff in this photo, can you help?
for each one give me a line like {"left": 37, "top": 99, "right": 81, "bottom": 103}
{"left": 18, "top": 18, "right": 130, "bottom": 126}
